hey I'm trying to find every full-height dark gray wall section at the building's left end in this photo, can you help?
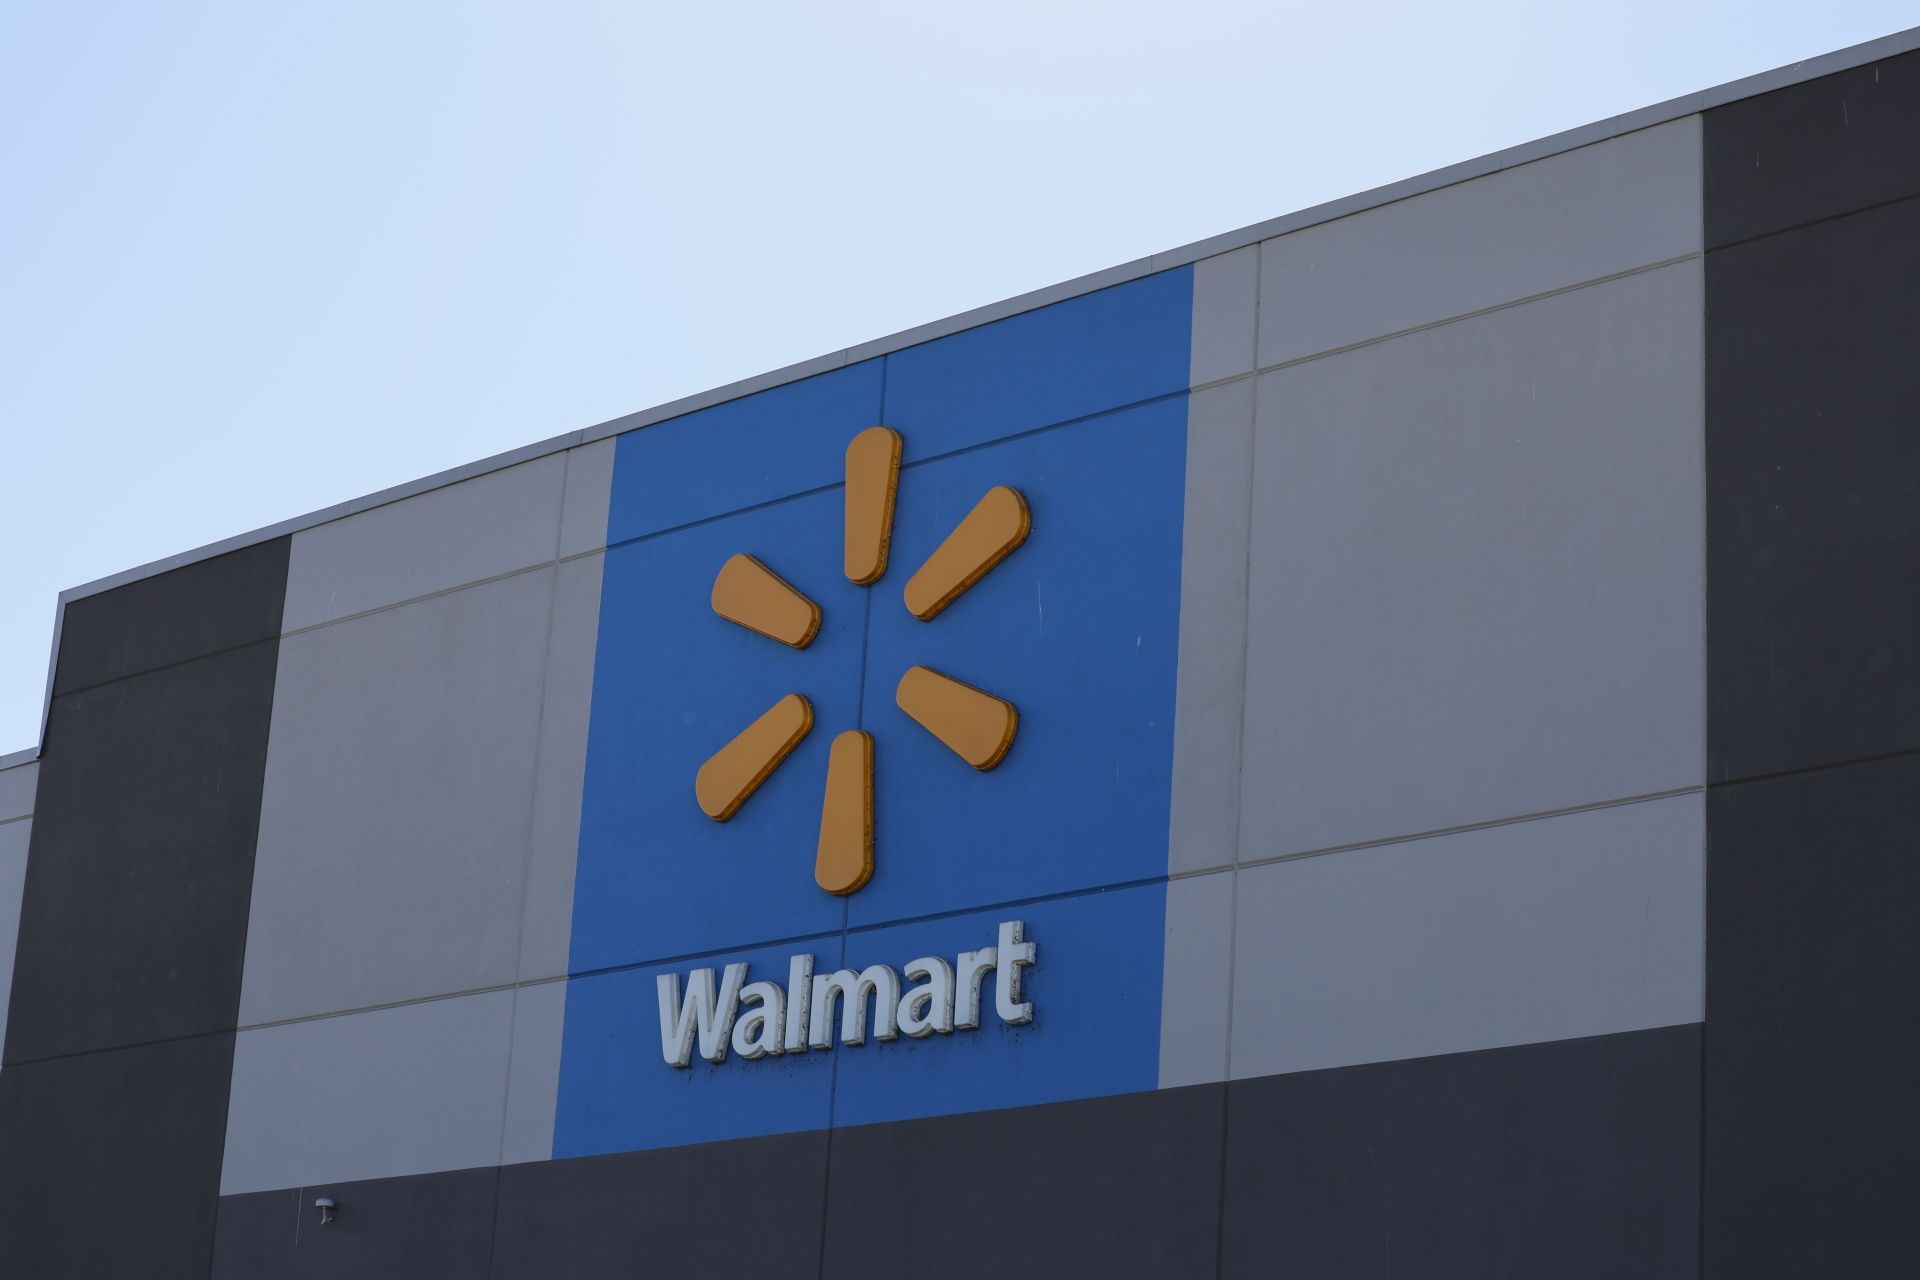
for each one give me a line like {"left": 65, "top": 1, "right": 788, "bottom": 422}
{"left": 0, "top": 539, "right": 286, "bottom": 1276}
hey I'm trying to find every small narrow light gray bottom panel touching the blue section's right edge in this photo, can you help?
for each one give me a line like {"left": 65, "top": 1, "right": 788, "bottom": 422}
{"left": 1160, "top": 871, "right": 1235, "bottom": 1088}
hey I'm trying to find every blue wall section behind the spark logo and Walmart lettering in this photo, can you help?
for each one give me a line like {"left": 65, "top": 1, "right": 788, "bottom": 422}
{"left": 555, "top": 269, "right": 1192, "bottom": 1155}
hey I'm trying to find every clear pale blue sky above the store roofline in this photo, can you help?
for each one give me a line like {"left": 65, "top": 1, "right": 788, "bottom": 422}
{"left": 0, "top": 0, "right": 1916, "bottom": 752}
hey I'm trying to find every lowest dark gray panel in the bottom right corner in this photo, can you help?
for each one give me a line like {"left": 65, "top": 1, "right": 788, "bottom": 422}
{"left": 1705, "top": 754, "right": 1920, "bottom": 1280}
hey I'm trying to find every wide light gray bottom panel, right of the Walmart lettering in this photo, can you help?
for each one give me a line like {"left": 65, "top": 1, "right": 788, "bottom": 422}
{"left": 1233, "top": 793, "right": 1705, "bottom": 1079}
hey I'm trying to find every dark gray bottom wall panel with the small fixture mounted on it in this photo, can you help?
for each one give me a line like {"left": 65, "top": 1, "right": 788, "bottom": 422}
{"left": 211, "top": 1169, "right": 499, "bottom": 1280}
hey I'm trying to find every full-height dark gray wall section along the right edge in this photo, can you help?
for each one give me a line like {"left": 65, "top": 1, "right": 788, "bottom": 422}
{"left": 1703, "top": 47, "right": 1920, "bottom": 1276}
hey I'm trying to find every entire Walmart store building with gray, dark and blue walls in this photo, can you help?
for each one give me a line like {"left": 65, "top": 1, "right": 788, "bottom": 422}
{"left": 0, "top": 33, "right": 1920, "bottom": 1278}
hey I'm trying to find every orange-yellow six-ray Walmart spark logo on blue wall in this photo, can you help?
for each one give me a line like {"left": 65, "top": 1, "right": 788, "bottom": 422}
{"left": 693, "top": 426, "right": 1033, "bottom": 894}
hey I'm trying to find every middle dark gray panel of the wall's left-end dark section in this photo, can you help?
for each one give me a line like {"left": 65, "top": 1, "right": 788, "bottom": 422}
{"left": 6, "top": 641, "right": 276, "bottom": 1059}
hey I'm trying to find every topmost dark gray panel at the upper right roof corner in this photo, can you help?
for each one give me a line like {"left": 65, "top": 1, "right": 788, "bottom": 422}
{"left": 1705, "top": 54, "right": 1920, "bottom": 248}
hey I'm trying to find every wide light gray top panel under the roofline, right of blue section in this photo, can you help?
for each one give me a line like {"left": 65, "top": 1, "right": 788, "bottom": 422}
{"left": 1260, "top": 115, "right": 1701, "bottom": 367}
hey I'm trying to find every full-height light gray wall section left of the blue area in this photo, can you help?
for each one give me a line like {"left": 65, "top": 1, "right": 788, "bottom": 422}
{"left": 221, "top": 445, "right": 611, "bottom": 1194}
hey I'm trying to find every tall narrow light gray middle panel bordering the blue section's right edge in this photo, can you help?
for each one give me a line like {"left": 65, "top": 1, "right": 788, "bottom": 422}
{"left": 1167, "top": 378, "right": 1254, "bottom": 871}
